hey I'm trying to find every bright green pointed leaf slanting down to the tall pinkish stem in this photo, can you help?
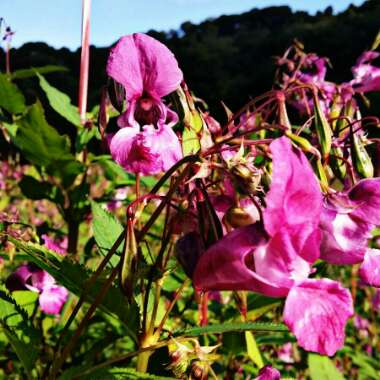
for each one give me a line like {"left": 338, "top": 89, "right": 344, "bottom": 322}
{"left": 37, "top": 73, "right": 80, "bottom": 126}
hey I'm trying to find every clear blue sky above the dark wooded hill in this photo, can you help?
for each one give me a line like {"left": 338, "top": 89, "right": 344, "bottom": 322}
{"left": 0, "top": 0, "right": 364, "bottom": 49}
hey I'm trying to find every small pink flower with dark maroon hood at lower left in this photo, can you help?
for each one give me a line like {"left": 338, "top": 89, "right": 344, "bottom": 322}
{"left": 6, "top": 264, "right": 68, "bottom": 314}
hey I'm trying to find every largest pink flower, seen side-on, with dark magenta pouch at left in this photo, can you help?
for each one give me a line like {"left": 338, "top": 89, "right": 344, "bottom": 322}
{"left": 193, "top": 137, "right": 353, "bottom": 355}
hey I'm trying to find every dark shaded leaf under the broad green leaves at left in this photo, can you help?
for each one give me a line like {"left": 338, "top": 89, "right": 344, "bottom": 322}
{"left": 19, "top": 175, "right": 64, "bottom": 204}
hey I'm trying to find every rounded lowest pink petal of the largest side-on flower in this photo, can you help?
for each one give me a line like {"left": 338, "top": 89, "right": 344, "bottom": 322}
{"left": 284, "top": 279, "right": 354, "bottom": 356}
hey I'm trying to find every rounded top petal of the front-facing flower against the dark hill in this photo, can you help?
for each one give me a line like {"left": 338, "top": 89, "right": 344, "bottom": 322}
{"left": 107, "top": 33, "right": 183, "bottom": 100}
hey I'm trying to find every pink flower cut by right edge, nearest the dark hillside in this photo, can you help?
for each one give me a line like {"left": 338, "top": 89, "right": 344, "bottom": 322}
{"left": 350, "top": 51, "right": 380, "bottom": 92}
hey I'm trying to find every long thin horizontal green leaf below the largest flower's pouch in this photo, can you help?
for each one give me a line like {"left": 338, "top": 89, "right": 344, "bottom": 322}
{"left": 173, "top": 322, "right": 289, "bottom": 336}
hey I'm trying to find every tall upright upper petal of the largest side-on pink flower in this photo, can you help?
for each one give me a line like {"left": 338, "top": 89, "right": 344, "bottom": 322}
{"left": 264, "top": 137, "right": 322, "bottom": 262}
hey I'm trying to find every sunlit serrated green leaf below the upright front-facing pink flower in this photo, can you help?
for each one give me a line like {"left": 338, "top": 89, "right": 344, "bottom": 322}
{"left": 91, "top": 202, "right": 124, "bottom": 254}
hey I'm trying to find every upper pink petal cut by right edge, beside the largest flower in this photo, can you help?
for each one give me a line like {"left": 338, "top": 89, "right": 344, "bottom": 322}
{"left": 348, "top": 178, "right": 380, "bottom": 225}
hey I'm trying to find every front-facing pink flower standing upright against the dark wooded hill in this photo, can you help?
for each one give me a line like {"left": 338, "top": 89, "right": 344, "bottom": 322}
{"left": 107, "top": 33, "right": 183, "bottom": 175}
